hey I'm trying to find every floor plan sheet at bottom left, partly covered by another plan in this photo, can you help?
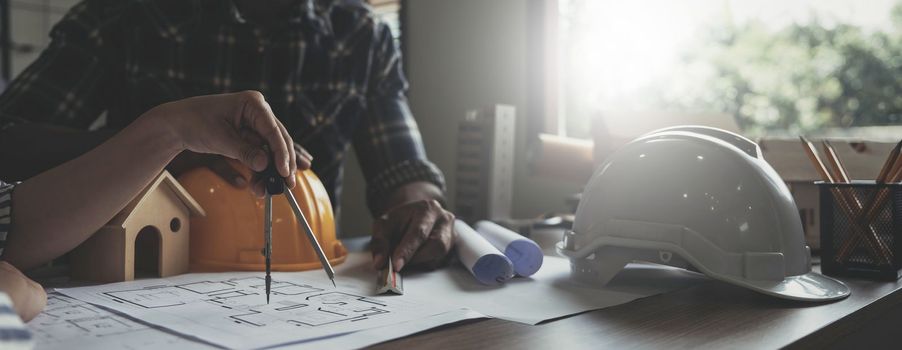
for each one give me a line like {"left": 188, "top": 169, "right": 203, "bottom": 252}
{"left": 28, "top": 293, "right": 215, "bottom": 350}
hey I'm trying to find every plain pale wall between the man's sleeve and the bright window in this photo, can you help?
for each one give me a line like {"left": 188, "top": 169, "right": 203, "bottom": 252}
{"left": 404, "top": 0, "right": 582, "bottom": 218}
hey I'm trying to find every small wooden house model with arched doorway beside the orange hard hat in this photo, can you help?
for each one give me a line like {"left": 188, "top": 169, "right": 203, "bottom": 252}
{"left": 70, "top": 170, "right": 205, "bottom": 282}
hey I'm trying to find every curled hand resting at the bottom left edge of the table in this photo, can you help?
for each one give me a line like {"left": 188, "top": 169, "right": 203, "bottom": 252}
{"left": 0, "top": 261, "right": 47, "bottom": 322}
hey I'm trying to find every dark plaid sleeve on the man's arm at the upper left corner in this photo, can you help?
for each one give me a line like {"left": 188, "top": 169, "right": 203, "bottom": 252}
{"left": 0, "top": 0, "right": 115, "bottom": 131}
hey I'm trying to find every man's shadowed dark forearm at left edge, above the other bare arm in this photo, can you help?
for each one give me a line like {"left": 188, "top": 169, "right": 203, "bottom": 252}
{"left": 0, "top": 123, "right": 114, "bottom": 181}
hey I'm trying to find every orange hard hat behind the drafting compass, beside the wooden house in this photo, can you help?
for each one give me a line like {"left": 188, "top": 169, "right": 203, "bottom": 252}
{"left": 179, "top": 161, "right": 348, "bottom": 272}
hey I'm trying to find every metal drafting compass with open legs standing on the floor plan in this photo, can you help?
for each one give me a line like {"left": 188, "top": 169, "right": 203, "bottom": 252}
{"left": 262, "top": 154, "right": 335, "bottom": 304}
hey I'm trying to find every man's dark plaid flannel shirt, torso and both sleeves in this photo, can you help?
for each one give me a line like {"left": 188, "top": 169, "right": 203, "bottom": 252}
{"left": 0, "top": 0, "right": 444, "bottom": 214}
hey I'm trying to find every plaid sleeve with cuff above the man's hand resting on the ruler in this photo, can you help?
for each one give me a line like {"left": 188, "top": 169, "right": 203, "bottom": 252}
{"left": 354, "top": 23, "right": 445, "bottom": 215}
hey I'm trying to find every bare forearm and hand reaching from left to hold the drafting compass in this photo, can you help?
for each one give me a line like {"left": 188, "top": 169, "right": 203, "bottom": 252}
{"left": 3, "top": 91, "right": 297, "bottom": 269}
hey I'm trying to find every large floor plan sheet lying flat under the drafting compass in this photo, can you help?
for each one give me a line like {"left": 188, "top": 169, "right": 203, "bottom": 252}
{"left": 60, "top": 273, "right": 463, "bottom": 348}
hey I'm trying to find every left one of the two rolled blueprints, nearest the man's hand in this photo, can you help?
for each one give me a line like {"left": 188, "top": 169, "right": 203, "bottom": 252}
{"left": 454, "top": 220, "right": 514, "bottom": 285}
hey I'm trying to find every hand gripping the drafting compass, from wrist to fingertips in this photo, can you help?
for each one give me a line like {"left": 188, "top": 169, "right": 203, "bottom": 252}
{"left": 145, "top": 91, "right": 300, "bottom": 194}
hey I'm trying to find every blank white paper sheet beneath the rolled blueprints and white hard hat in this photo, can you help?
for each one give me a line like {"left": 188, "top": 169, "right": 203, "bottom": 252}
{"left": 301, "top": 253, "right": 709, "bottom": 324}
